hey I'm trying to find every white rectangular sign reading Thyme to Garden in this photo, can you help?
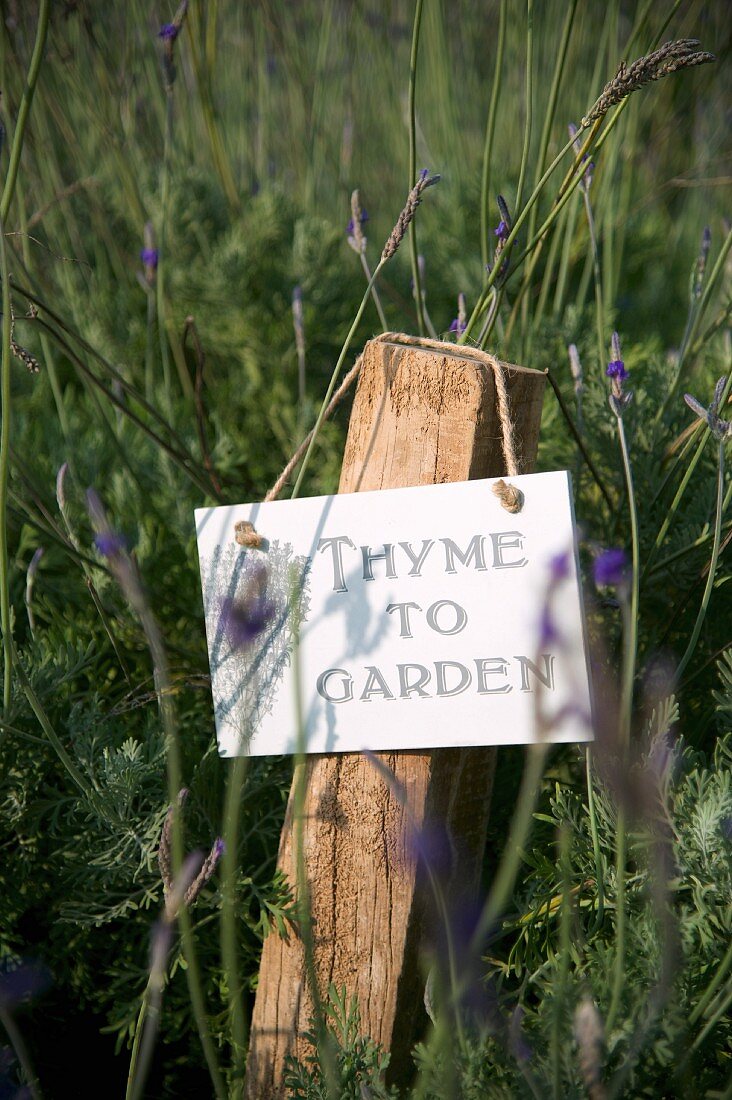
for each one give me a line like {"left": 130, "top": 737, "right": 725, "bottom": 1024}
{"left": 196, "top": 472, "right": 592, "bottom": 756}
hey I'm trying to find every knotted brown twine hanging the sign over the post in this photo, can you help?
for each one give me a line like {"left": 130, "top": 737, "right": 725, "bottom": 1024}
{"left": 234, "top": 332, "right": 524, "bottom": 550}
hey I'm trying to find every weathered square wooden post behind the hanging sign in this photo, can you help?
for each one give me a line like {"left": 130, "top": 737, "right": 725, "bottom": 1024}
{"left": 247, "top": 334, "right": 545, "bottom": 1100}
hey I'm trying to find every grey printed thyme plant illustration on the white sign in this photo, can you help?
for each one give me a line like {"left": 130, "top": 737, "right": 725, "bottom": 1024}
{"left": 200, "top": 539, "right": 309, "bottom": 751}
